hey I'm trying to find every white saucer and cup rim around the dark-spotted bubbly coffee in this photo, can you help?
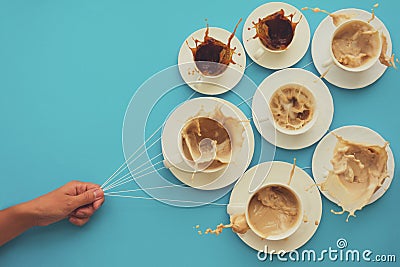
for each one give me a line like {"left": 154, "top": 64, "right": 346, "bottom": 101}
{"left": 252, "top": 68, "right": 334, "bottom": 149}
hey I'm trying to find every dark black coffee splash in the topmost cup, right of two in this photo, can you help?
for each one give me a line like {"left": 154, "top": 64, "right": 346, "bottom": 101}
{"left": 252, "top": 9, "right": 302, "bottom": 50}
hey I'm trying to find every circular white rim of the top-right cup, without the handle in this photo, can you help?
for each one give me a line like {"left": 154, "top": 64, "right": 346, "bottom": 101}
{"left": 329, "top": 19, "right": 382, "bottom": 72}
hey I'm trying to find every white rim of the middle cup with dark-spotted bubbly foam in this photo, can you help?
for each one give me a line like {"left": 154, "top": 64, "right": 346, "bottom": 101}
{"left": 268, "top": 82, "right": 319, "bottom": 135}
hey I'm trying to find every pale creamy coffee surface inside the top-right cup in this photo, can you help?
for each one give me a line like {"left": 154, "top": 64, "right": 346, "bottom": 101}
{"left": 332, "top": 20, "right": 381, "bottom": 68}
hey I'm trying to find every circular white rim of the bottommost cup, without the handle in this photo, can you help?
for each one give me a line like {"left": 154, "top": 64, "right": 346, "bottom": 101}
{"left": 245, "top": 182, "right": 304, "bottom": 240}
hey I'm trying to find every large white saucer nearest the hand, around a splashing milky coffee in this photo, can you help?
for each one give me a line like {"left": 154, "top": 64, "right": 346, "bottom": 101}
{"left": 161, "top": 97, "right": 254, "bottom": 190}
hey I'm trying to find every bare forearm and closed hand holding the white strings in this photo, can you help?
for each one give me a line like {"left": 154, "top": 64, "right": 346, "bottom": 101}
{"left": 0, "top": 181, "right": 104, "bottom": 246}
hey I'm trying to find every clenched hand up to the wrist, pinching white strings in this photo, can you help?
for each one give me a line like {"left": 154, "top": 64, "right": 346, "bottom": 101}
{"left": 26, "top": 181, "right": 104, "bottom": 226}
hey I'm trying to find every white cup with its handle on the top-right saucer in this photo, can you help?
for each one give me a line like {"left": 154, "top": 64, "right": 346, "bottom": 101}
{"left": 322, "top": 19, "right": 382, "bottom": 72}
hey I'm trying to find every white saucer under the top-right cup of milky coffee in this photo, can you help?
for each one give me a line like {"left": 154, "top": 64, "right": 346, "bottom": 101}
{"left": 311, "top": 8, "right": 392, "bottom": 89}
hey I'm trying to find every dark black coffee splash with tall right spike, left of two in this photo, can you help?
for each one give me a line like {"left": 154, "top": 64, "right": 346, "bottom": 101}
{"left": 186, "top": 19, "right": 242, "bottom": 76}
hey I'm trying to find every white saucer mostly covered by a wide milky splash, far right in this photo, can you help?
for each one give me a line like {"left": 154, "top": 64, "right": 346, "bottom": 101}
{"left": 312, "top": 126, "right": 394, "bottom": 204}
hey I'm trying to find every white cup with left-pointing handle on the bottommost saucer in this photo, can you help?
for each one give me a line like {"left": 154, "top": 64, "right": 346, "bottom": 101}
{"left": 228, "top": 183, "right": 303, "bottom": 240}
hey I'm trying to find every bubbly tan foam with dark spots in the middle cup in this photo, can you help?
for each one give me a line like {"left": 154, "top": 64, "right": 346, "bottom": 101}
{"left": 269, "top": 84, "right": 316, "bottom": 130}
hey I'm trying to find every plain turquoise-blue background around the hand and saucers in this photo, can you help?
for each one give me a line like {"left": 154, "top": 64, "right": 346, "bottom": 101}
{"left": 0, "top": 0, "right": 400, "bottom": 267}
